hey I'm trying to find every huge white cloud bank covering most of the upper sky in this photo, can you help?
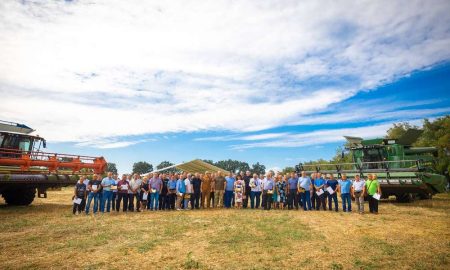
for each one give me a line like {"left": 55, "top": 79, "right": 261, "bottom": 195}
{"left": 0, "top": 0, "right": 450, "bottom": 144}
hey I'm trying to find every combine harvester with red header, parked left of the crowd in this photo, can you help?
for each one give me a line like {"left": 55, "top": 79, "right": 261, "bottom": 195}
{"left": 0, "top": 120, "right": 107, "bottom": 205}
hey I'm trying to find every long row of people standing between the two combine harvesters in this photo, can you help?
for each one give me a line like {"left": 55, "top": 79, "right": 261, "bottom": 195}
{"left": 73, "top": 171, "right": 381, "bottom": 215}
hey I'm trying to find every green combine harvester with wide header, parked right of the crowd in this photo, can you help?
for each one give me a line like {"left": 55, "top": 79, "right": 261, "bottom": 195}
{"left": 296, "top": 129, "right": 447, "bottom": 202}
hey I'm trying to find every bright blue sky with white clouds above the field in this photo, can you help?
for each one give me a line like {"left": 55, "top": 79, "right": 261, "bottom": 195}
{"left": 0, "top": 0, "right": 450, "bottom": 173}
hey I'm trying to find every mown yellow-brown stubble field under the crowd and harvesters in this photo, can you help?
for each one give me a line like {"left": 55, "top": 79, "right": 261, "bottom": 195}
{"left": 0, "top": 189, "right": 450, "bottom": 269}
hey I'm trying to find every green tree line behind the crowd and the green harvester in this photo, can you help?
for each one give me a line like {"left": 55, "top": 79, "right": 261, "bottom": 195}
{"left": 108, "top": 115, "right": 450, "bottom": 177}
